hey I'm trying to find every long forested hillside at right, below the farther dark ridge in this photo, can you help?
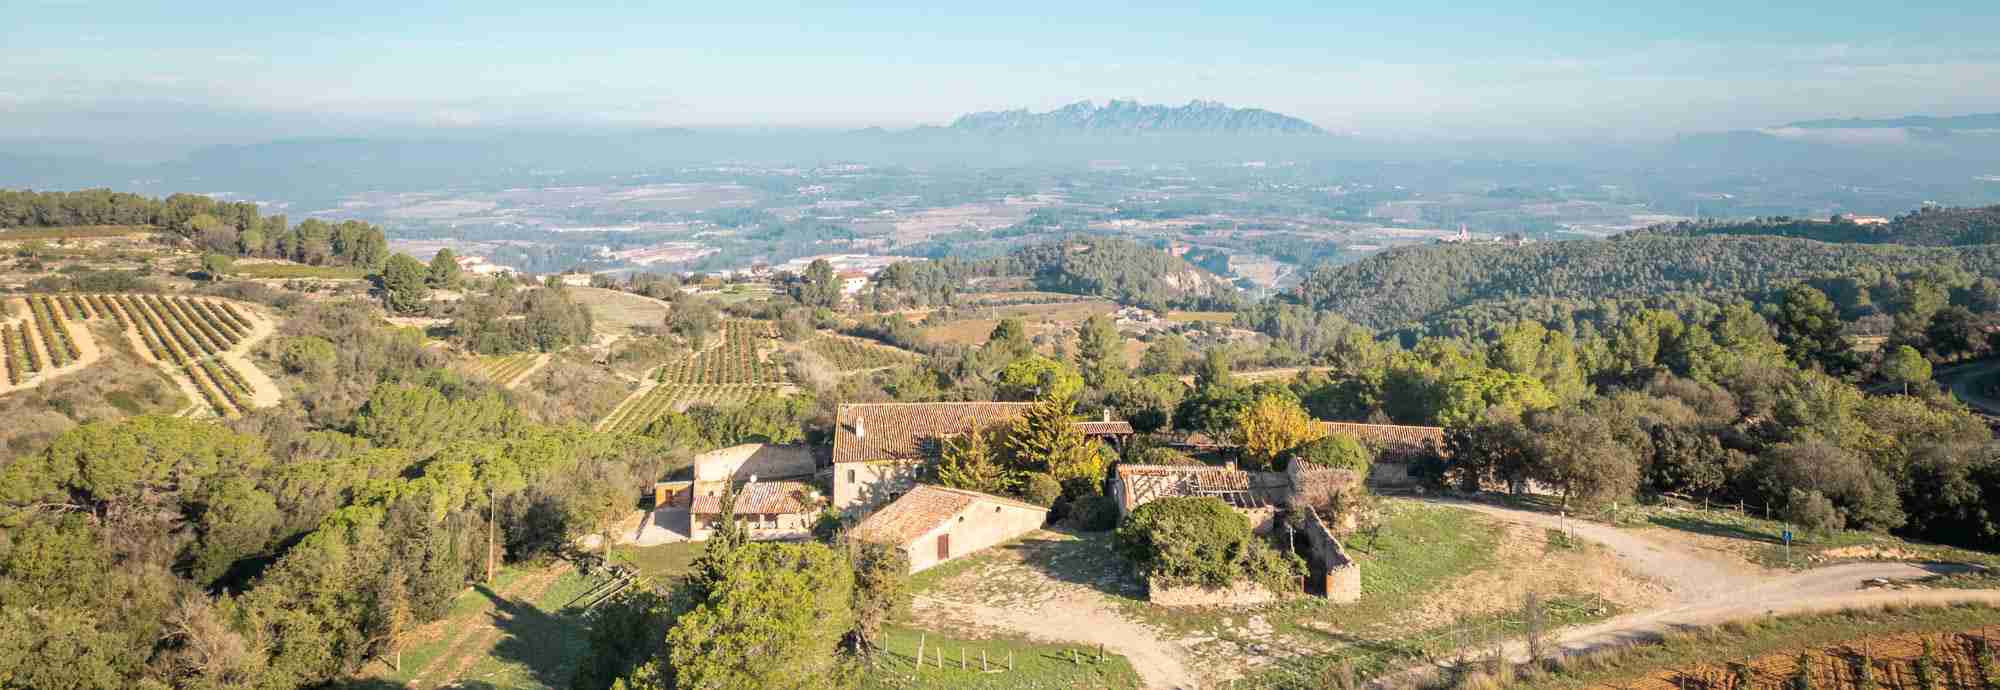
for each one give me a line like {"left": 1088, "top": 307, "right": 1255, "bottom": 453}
{"left": 1294, "top": 234, "right": 2000, "bottom": 328}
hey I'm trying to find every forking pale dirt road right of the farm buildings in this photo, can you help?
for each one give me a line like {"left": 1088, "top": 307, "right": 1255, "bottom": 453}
{"left": 1368, "top": 498, "right": 2000, "bottom": 688}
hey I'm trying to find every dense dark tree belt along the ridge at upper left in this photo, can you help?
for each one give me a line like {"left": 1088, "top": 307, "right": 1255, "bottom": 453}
{"left": 0, "top": 190, "right": 388, "bottom": 268}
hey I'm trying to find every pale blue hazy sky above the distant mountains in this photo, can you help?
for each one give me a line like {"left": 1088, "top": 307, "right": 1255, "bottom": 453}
{"left": 0, "top": 0, "right": 2000, "bottom": 136}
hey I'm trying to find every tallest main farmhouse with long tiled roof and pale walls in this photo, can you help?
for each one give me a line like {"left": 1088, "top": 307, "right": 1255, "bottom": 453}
{"left": 834, "top": 402, "right": 1132, "bottom": 514}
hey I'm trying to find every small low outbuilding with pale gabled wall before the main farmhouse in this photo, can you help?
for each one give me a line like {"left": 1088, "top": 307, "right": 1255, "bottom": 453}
{"left": 854, "top": 484, "right": 1048, "bottom": 572}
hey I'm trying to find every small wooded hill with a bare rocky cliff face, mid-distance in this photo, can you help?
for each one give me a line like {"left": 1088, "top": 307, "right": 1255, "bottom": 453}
{"left": 996, "top": 236, "right": 1240, "bottom": 310}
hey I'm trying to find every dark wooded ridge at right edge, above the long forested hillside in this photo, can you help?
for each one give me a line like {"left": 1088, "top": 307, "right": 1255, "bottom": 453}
{"left": 1632, "top": 206, "right": 2000, "bottom": 246}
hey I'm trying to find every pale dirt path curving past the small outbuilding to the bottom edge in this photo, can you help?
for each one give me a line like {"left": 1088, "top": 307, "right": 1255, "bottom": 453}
{"left": 910, "top": 590, "right": 1200, "bottom": 690}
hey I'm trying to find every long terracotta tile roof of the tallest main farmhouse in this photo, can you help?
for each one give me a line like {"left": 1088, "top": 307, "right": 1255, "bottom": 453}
{"left": 834, "top": 402, "right": 1132, "bottom": 464}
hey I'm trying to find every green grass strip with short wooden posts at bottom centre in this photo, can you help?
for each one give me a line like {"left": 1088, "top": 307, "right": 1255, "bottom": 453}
{"left": 862, "top": 626, "right": 1140, "bottom": 690}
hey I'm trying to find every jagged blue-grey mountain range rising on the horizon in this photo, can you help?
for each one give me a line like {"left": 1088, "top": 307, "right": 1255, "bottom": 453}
{"left": 950, "top": 100, "right": 1326, "bottom": 134}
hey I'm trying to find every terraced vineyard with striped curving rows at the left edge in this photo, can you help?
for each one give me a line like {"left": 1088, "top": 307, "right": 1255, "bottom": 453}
{"left": 0, "top": 294, "right": 278, "bottom": 416}
